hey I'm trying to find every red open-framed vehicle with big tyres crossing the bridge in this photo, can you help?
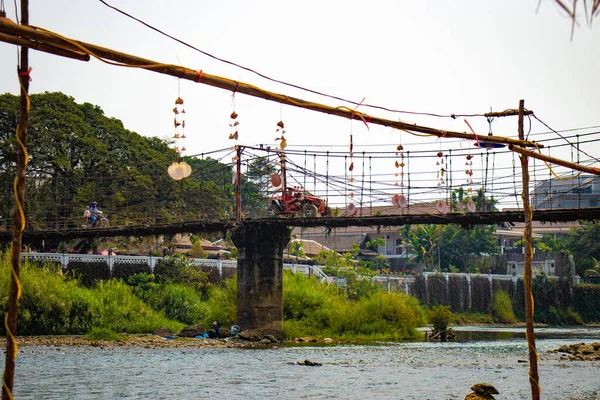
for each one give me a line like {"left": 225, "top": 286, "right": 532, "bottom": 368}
{"left": 267, "top": 186, "right": 331, "bottom": 218}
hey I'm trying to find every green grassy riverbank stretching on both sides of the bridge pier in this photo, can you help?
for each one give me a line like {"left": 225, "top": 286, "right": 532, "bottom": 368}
{"left": 0, "top": 254, "right": 426, "bottom": 340}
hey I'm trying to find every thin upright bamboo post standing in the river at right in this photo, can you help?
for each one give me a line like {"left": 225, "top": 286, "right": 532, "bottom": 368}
{"left": 519, "top": 100, "right": 540, "bottom": 400}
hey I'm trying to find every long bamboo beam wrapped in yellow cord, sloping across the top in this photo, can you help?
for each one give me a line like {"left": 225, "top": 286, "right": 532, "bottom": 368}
{"left": 0, "top": 22, "right": 543, "bottom": 147}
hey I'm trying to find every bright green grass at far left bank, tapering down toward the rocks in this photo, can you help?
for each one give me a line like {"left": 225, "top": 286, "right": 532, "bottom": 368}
{"left": 0, "top": 254, "right": 184, "bottom": 335}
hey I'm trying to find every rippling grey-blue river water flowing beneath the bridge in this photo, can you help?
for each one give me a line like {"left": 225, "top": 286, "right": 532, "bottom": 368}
{"left": 2, "top": 328, "right": 600, "bottom": 400}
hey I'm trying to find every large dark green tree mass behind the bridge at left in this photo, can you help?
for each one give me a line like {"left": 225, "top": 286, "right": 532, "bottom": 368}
{"left": 0, "top": 93, "right": 232, "bottom": 233}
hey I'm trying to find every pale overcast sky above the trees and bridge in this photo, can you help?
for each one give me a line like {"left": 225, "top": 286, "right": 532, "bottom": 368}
{"left": 0, "top": 0, "right": 600, "bottom": 209}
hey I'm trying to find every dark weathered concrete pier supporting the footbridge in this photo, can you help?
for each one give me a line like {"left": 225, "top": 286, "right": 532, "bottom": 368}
{"left": 231, "top": 223, "right": 291, "bottom": 338}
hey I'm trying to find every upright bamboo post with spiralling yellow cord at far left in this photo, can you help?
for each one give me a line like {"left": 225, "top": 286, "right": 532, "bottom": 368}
{"left": 2, "top": 0, "right": 29, "bottom": 400}
